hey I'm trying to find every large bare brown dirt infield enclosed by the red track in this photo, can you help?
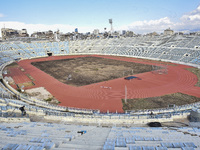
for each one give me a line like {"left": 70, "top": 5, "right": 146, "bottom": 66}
{"left": 32, "top": 57, "right": 152, "bottom": 86}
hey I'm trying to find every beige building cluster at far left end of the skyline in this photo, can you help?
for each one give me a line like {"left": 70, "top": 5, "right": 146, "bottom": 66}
{"left": 1, "top": 28, "right": 29, "bottom": 41}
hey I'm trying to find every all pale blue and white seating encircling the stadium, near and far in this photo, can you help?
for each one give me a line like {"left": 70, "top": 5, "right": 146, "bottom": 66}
{"left": 0, "top": 35, "right": 200, "bottom": 150}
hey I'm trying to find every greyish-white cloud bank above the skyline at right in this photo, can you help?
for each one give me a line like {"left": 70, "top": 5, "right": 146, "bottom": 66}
{"left": 119, "top": 6, "right": 200, "bottom": 34}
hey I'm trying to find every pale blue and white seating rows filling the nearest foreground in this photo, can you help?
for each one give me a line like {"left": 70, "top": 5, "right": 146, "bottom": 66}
{"left": 0, "top": 122, "right": 200, "bottom": 150}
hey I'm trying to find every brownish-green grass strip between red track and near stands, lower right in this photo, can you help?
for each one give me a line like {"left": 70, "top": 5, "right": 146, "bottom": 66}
{"left": 122, "top": 93, "right": 200, "bottom": 111}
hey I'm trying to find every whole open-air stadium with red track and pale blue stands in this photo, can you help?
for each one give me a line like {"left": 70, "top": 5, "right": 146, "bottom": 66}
{"left": 0, "top": 35, "right": 200, "bottom": 150}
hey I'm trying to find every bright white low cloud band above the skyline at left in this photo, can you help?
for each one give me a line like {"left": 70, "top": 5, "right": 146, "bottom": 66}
{"left": 0, "top": 21, "right": 93, "bottom": 34}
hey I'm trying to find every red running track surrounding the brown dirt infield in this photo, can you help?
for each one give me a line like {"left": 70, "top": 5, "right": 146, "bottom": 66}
{"left": 13, "top": 55, "right": 200, "bottom": 112}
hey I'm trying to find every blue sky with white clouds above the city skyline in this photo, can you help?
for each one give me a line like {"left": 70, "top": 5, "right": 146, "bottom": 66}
{"left": 0, "top": 0, "right": 200, "bottom": 36}
